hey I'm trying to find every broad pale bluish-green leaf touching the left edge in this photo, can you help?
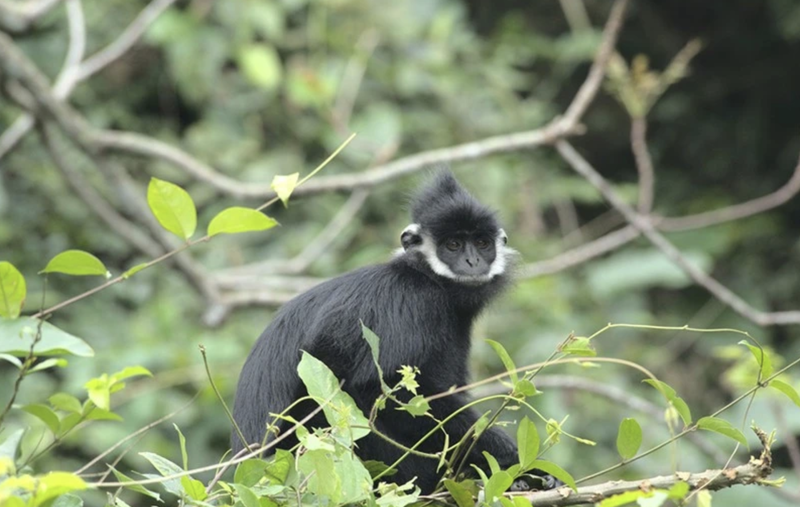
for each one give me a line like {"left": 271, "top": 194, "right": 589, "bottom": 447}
{"left": 0, "top": 317, "right": 94, "bottom": 357}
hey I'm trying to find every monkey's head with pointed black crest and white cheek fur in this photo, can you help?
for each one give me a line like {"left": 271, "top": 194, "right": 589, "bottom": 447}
{"left": 400, "top": 170, "right": 515, "bottom": 285}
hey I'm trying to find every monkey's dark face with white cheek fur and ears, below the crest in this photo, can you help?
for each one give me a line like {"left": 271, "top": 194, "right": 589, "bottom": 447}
{"left": 401, "top": 224, "right": 513, "bottom": 285}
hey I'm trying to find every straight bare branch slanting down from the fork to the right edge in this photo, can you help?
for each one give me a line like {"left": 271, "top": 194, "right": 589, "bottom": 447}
{"left": 555, "top": 140, "right": 800, "bottom": 326}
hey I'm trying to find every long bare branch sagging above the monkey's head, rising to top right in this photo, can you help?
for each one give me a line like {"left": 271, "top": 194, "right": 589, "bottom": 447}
{"left": 0, "top": 0, "right": 628, "bottom": 198}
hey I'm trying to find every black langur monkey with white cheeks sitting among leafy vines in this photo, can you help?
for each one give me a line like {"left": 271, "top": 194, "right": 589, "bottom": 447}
{"left": 231, "top": 171, "right": 558, "bottom": 493}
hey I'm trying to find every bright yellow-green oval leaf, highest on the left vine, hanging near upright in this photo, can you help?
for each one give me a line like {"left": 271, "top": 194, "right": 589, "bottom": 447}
{"left": 147, "top": 178, "right": 197, "bottom": 239}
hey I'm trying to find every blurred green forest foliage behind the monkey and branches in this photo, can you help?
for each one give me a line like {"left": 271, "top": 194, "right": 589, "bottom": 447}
{"left": 0, "top": 0, "right": 800, "bottom": 507}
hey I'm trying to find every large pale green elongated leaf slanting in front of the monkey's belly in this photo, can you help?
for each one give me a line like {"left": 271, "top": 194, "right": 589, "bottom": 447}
{"left": 297, "top": 351, "right": 369, "bottom": 442}
